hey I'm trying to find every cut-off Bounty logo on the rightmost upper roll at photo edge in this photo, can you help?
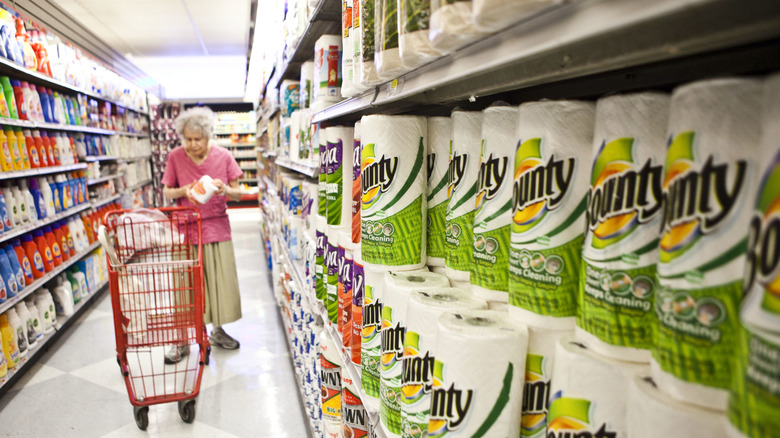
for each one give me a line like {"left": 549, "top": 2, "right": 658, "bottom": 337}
{"left": 744, "top": 153, "right": 780, "bottom": 315}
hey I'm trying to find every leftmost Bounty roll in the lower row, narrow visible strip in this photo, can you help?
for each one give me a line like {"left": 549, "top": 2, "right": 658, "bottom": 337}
{"left": 360, "top": 266, "right": 387, "bottom": 412}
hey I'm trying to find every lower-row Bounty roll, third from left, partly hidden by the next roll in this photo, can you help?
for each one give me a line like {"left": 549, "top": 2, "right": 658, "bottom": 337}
{"left": 401, "top": 287, "right": 487, "bottom": 438}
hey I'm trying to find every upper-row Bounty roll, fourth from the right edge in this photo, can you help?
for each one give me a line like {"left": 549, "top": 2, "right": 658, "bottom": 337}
{"left": 509, "top": 101, "right": 595, "bottom": 329}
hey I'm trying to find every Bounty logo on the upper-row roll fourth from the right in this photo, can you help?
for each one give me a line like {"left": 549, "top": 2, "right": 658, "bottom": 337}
{"left": 512, "top": 138, "right": 576, "bottom": 233}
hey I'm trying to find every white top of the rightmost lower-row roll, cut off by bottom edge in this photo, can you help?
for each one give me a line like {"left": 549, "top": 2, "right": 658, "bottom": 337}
{"left": 626, "top": 374, "right": 727, "bottom": 438}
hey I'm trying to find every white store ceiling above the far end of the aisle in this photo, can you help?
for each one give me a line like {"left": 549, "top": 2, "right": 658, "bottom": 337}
{"left": 54, "top": 0, "right": 253, "bottom": 101}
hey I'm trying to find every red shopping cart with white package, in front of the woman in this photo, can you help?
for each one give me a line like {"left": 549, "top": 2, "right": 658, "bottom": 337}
{"left": 98, "top": 207, "right": 211, "bottom": 430}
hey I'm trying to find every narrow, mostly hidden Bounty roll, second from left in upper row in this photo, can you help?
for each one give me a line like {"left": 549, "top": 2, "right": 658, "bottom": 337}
{"left": 426, "top": 116, "right": 452, "bottom": 266}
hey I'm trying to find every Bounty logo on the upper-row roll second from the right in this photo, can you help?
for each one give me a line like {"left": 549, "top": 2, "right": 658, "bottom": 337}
{"left": 660, "top": 131, "right": 747, "bottom": 263}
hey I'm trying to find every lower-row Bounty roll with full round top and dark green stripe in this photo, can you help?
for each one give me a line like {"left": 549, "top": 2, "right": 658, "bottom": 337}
{"left": 428, "top": 310, "right": 528, "bottom": 437}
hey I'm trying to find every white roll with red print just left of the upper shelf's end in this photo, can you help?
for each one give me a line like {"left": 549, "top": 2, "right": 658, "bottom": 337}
{"left": 312, "top": 35, "right": 342, "bottom": 104}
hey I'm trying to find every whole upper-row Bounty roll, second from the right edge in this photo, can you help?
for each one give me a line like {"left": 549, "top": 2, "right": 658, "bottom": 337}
{"left": 651, "top": 78, "right": 761, "bottom": 410}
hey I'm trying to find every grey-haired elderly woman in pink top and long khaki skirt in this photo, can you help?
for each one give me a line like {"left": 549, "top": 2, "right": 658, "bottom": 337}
{"left": 162, "top": 107, "right": 243, "bottom": 363}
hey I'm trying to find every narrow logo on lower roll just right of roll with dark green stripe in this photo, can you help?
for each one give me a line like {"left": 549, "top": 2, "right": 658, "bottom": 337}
{"left": 520, "top": 353, "right": 550, "bottom": 437}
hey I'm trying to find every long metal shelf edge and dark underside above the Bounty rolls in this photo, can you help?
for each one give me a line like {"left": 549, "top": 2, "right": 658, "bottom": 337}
{"left": 314, "top": 0, "right": 780, "bottom": 122}
